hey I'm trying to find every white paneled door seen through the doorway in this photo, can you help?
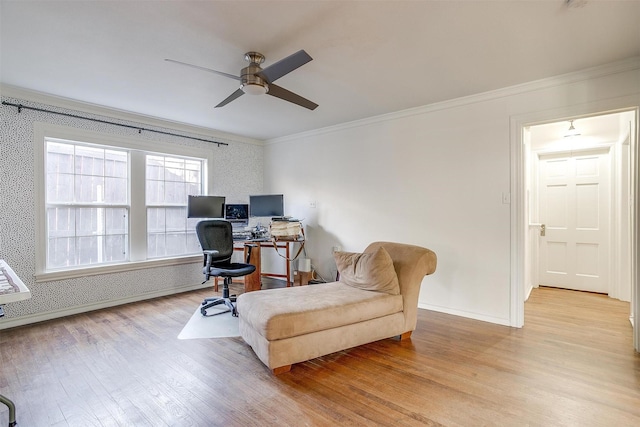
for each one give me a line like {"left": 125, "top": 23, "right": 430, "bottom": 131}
{"left": 538, "top": 149, "right": 610, "bottom": 293}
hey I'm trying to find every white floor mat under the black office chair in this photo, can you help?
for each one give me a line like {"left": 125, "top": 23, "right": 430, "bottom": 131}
{"left": 178, "top": 306, "right": 240, "bottom": 340}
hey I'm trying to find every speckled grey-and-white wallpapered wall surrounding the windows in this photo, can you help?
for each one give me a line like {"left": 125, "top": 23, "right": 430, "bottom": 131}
{"left": 0, "top": 97, "right": 263, "bottom": 319}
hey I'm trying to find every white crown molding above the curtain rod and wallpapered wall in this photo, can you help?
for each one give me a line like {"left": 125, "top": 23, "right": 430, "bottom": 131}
{"left": 0, "top": 83, "right": 263, "bottom": 145}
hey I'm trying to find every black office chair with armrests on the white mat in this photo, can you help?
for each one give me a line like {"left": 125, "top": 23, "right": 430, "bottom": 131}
{"left": 196, "top": 220, "right": 256, "bottom": 316}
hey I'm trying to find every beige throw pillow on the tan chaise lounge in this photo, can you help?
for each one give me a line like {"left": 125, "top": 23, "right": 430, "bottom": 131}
{"left": 333, "top": 247, "right": 400, "bottom": 295}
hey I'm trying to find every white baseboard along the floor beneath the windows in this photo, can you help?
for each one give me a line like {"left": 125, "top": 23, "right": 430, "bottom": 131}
{"left": 0, "top": 282, "right": 213, "bottom": 330}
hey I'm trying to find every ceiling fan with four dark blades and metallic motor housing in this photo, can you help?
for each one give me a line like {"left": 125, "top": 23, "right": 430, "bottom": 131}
{"left": 165, "top": 50, "right": 318, "bottom": 110}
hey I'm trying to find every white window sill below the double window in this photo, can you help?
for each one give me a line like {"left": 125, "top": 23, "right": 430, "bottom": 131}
{"left": 35, "top": 255, "right": 202, "bottom": 283}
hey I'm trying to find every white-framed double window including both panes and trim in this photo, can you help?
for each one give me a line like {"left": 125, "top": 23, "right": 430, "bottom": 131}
{"left": 35, "top": 124, "right": 212, "bottom": 280}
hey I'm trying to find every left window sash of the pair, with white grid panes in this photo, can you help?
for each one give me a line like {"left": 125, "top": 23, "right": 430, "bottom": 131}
{"left": 45, "top": 140, "right": 129, "bottom": 269}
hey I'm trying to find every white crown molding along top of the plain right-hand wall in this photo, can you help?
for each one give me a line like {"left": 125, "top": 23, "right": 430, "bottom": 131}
{"left": 265, "top": 56, "right": 640, "bottom": 145}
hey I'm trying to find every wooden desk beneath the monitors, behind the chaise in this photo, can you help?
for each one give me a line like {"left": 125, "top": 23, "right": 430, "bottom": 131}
{"left": 214, "top": 238, "right": 305, "bottom": 292}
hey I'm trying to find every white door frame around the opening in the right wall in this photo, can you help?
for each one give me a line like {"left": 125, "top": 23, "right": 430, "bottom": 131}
{"left": 509, "top": 102, "right": 640, "bottom": 352}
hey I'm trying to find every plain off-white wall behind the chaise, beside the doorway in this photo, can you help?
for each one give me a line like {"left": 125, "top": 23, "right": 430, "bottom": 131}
{"left": 264, "top": 59, "right": 640, "bottom": 325}
